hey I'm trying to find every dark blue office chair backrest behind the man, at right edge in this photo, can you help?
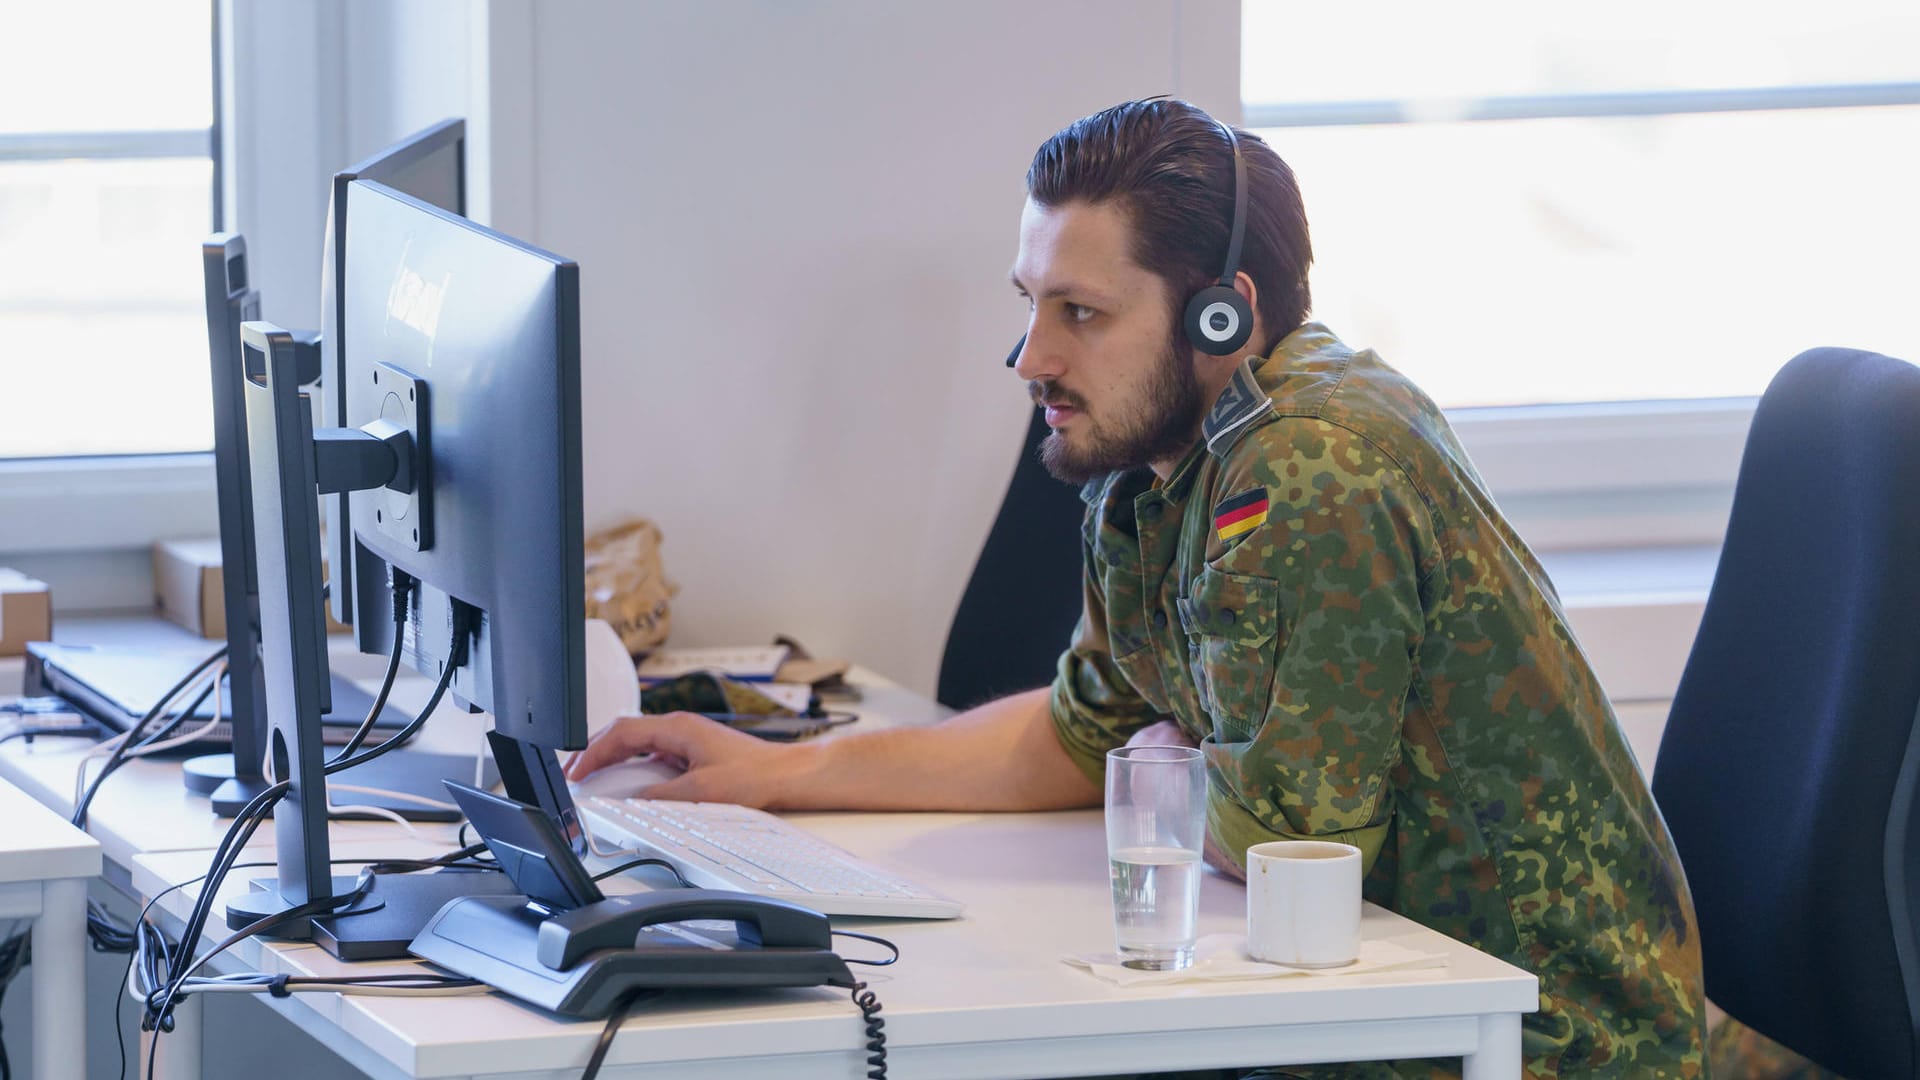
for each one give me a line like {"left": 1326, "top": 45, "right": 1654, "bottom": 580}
{"left": 1653, "top": 348, "right": 1920, "bottom": 1080}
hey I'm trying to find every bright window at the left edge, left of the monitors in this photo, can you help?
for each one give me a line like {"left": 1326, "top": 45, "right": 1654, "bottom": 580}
{"left": 0, "top": 0, "right": 217, "bottom": 459}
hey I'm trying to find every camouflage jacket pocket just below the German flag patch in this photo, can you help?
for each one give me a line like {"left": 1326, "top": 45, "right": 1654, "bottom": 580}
{"left": 1179, "top": 569, "right": 1281, "bottom": 742}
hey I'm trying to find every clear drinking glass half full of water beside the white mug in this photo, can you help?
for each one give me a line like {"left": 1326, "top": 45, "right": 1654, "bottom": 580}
{"left": 1106, "top": 746, "right": 1206, "bottom": 970}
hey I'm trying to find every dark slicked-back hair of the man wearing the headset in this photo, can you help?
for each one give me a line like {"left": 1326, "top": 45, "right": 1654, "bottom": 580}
{"left": 1027, "top": 98, "right": 1313, "bottom": 348}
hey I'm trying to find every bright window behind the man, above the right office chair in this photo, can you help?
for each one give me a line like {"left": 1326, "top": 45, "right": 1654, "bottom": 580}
{"left": 1240, "top": 0, "right": 1920, "bottom": 407}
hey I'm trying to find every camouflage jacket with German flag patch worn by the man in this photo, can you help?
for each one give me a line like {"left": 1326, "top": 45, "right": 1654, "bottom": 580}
{"left": 1052, "top": 323, "right": 1705, "bottom": 1078}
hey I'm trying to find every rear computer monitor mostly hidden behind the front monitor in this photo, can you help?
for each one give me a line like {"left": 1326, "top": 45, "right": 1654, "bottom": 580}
{"left": 321, "top": 119, "right": 467, "bottom": 626}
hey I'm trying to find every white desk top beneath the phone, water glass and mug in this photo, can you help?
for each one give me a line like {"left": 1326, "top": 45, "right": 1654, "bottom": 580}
{"left": 134, "top": 811, "right": 1538, "bottom": 1080}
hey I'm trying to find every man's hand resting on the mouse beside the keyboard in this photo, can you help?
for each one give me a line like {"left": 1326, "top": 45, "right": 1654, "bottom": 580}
{"left": 566, "top": 713, "right": 804, "bottom": 807}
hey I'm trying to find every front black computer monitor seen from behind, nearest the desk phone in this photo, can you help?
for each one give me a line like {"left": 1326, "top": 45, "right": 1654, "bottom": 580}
{"left": 342, "top": 181, "right": 588, "bottom": 838}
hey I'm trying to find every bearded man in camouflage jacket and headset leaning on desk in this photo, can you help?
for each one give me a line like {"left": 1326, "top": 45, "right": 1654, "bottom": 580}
{"left": 572, "top": 100, "right": 1703, "bottom": 1078}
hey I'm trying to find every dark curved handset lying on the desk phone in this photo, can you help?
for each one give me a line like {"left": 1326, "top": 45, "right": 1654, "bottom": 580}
{"left": 536, "top": 888, "right": 833, "bottom": 970}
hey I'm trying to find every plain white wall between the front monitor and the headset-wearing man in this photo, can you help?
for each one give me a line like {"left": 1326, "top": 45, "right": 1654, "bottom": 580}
{"left": 474, "top": 0, "right": 1238, "bottom": 690}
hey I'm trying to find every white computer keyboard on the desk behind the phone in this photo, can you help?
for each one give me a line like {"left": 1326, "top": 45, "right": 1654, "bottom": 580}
{"left": 580, "top": 796, "right": 960, "bottom": 919}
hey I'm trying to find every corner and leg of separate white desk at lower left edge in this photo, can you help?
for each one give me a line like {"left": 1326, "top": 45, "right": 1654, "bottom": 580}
{"left": 0, "top": 768, "right": 100, "bottom": 1080}
